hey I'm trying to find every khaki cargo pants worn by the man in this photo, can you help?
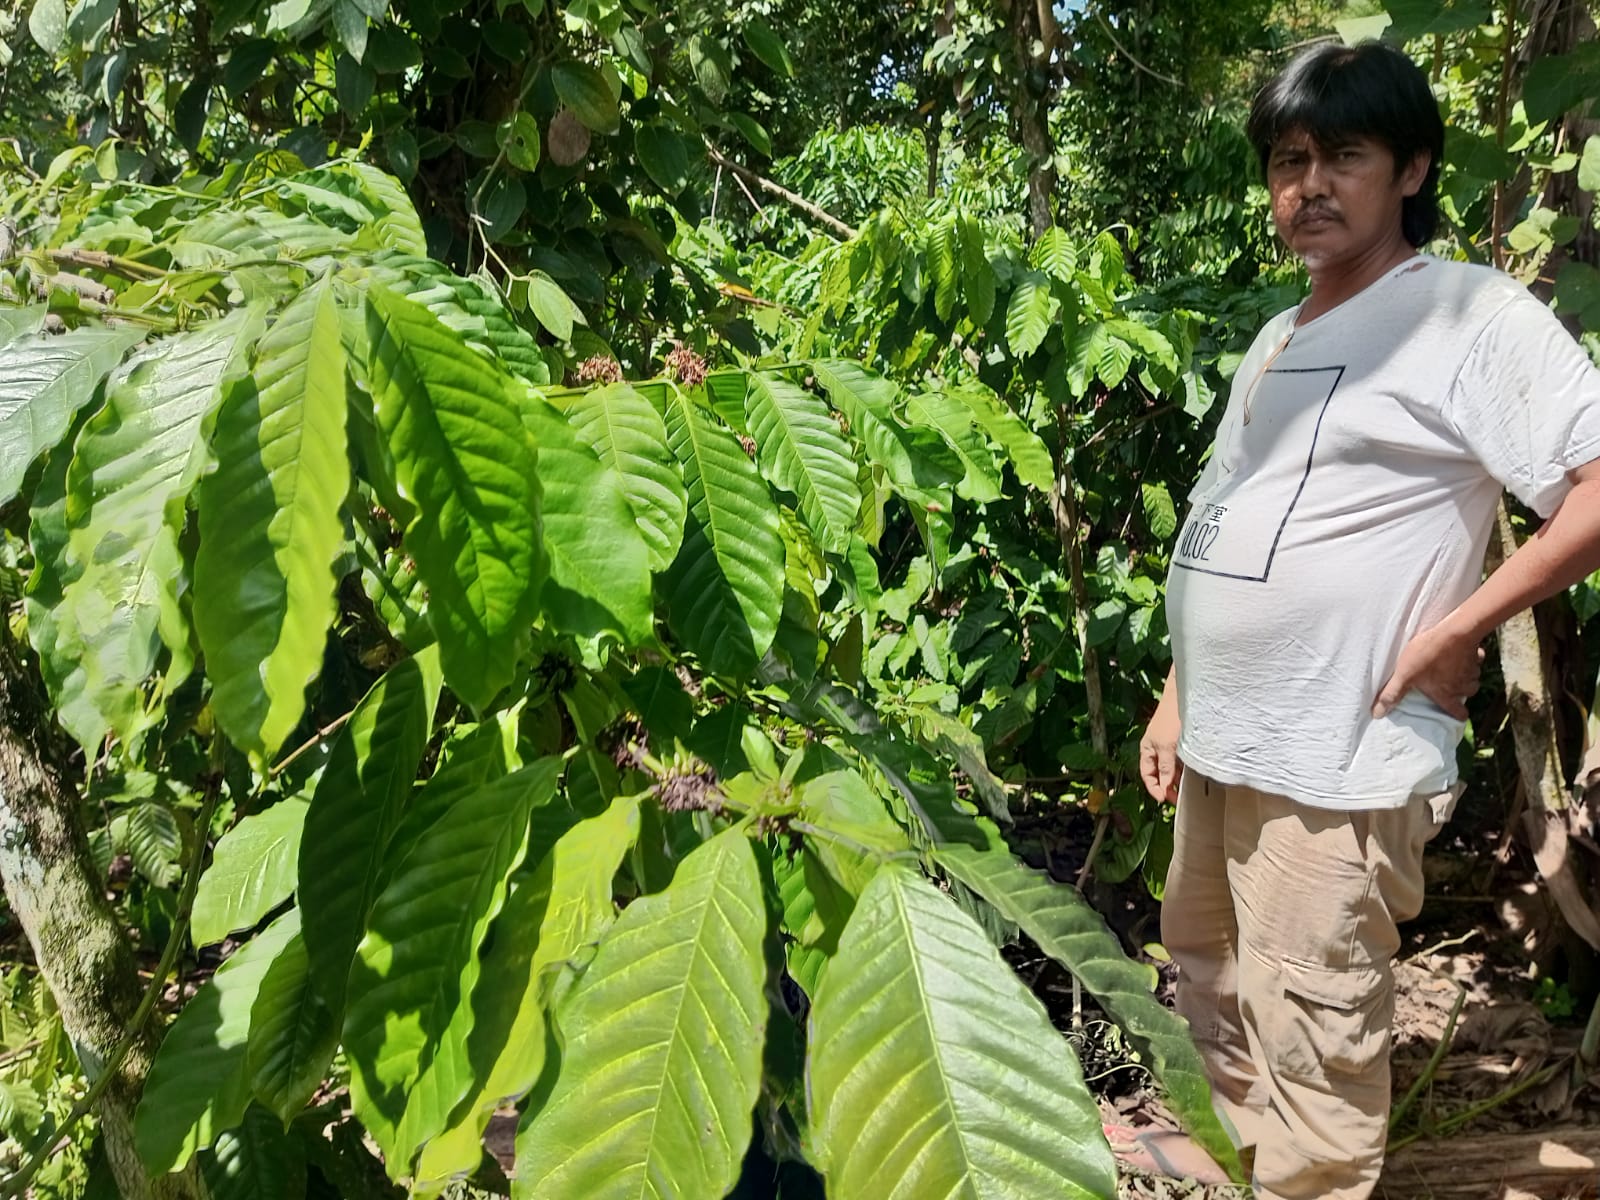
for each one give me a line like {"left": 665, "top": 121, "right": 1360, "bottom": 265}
{"left": 1162, "top": 771, "right": 1451, "bottom": 1200}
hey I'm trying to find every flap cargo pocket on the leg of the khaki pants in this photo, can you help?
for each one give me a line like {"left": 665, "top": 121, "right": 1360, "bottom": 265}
{"left": 1262, "top": 958, "right": 1395, "bottom": 1082}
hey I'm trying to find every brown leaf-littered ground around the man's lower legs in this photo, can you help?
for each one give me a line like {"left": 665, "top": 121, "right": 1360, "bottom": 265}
{"left": 1011, "top": 794, "right": 1600, "bottom": 1200}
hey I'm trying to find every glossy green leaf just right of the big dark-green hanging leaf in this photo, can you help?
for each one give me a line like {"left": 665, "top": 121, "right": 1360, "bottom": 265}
{"left": 522, "top": 392, "right": 654, "bottom": 645}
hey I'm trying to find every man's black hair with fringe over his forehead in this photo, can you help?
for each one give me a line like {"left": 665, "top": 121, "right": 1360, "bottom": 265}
{"left": 1245, "top": 42, "right": 1445, "bottom": 246}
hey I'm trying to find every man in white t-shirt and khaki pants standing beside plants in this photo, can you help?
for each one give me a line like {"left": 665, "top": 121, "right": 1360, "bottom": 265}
{"left": 1141, "top": 43, "right": 1600, "bottom": 1200}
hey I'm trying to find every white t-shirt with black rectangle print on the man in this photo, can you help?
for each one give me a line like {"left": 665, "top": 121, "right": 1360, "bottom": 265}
{"left": 1166, "top": 258, "right": 1600, "bottom": 808}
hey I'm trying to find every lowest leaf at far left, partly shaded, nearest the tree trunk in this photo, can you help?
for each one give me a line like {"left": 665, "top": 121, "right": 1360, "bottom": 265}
{"left": 133, "top": 909, "right": 299, "bottom": 1174}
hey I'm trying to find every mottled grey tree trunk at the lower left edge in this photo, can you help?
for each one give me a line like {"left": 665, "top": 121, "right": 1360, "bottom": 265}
{"left": 0, "top": 635, "right": 200, "bottom": 1200}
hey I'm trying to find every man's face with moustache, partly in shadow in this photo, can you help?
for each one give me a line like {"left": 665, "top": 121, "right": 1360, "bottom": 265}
{"left": 1267, "top": 130, "right": 1429, "bottom": 270}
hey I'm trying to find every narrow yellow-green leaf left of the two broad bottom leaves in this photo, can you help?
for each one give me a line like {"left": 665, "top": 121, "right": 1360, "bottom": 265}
{"left": 416, "top": 797, "right": 638, "bottom": 1186}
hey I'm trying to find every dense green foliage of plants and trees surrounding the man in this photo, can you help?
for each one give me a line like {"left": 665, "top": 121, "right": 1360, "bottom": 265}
{"left": 0, "top": 0, "right": 1600, "bottom": 1200}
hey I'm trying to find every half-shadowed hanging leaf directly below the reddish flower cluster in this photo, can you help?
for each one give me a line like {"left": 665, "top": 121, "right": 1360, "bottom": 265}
{"left": 666, "top": 389, "right": 784, "bottom": 675}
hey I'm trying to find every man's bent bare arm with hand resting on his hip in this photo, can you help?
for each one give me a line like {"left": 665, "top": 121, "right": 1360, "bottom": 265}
{"left": 1373, "top": 459, "right": 1600, "bottom": 718}
